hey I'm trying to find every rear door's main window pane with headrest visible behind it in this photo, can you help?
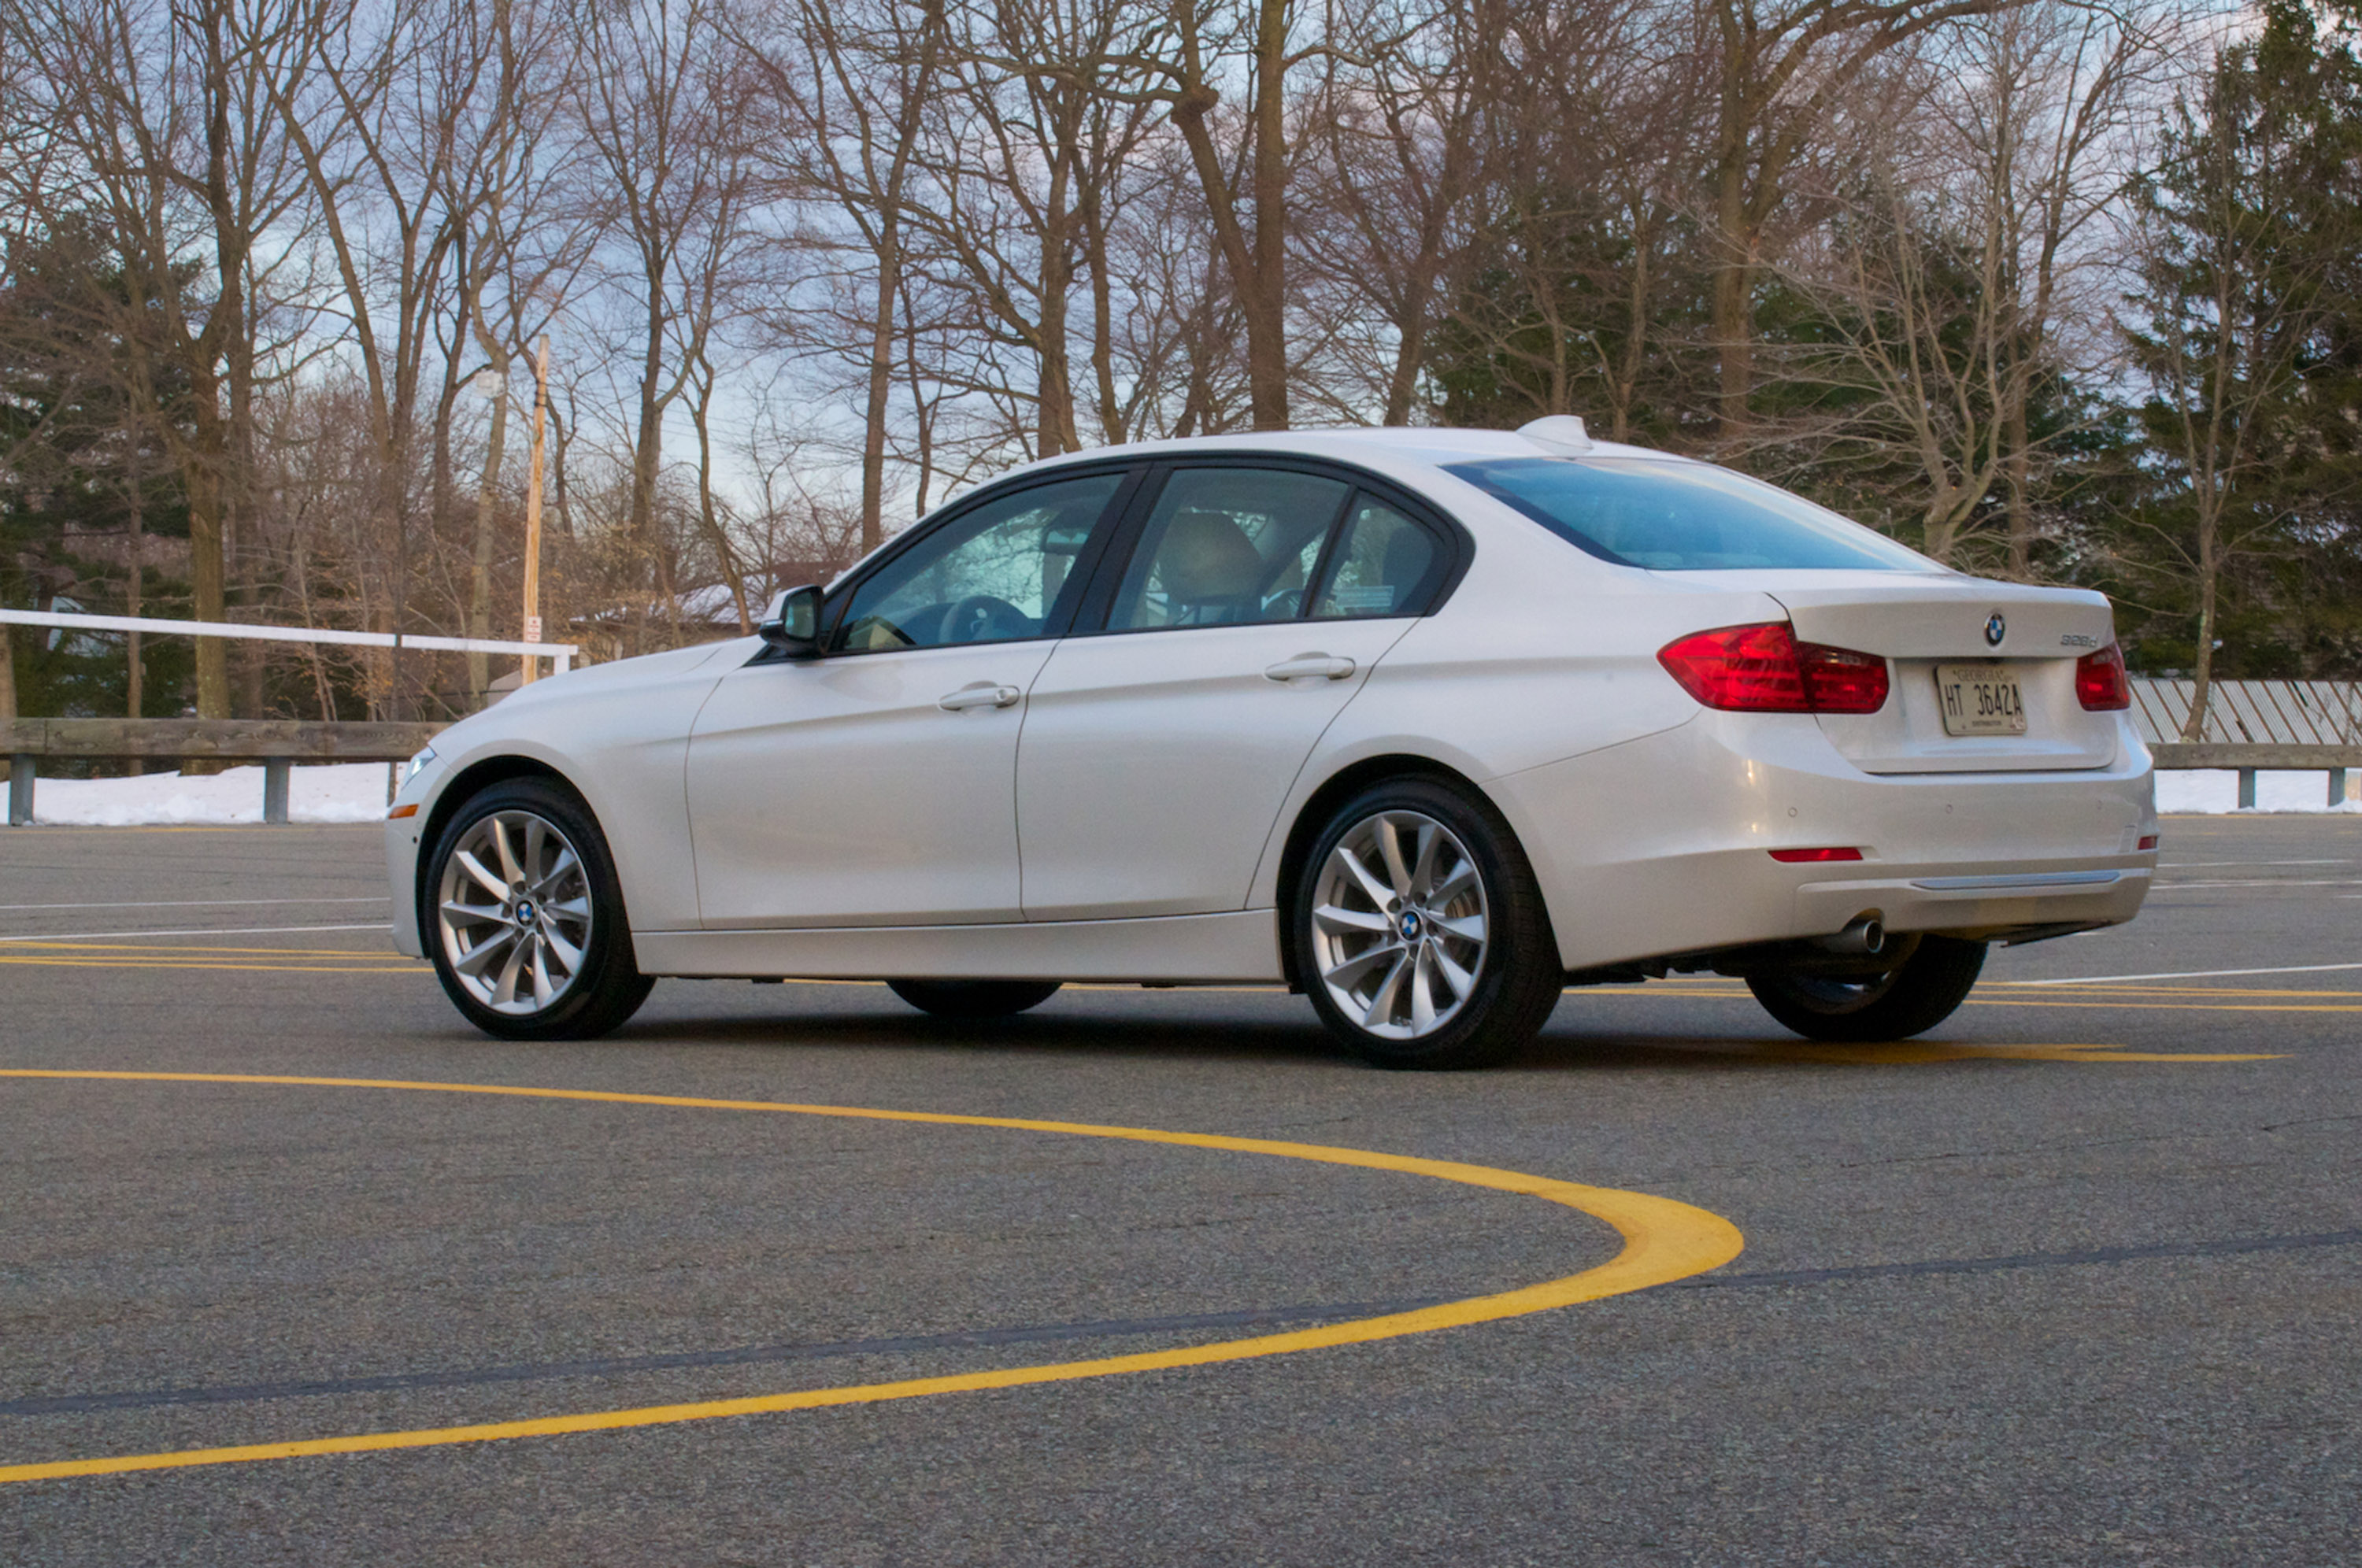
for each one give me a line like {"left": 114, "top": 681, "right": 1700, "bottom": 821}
{"left": 1108, "top": 468, "right": 1351, "bottom": 631}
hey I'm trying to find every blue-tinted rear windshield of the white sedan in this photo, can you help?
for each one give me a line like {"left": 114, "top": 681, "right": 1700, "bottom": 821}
{"left": 1446, "top": 458, "right": 1942, "bottom": 571}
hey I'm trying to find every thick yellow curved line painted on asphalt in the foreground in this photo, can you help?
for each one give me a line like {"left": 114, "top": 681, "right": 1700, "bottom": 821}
{"left": 0, "top": 1067, "right": 1746, "bottom": 1483}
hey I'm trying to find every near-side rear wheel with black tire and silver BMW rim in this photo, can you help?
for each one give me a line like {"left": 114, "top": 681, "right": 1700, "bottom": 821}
{"left": 1287, "top": 777, "right": 1566, "bottom": 1070}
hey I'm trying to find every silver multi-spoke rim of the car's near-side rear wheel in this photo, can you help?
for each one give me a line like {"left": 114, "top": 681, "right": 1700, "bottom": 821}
{"left": 1313, "top": 810, "right": 1490, "bottom": 1039}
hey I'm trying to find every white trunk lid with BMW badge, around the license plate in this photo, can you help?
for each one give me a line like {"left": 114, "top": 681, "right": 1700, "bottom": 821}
{"left": 1755, "top": 571, "right": 2119, "bottom": 772}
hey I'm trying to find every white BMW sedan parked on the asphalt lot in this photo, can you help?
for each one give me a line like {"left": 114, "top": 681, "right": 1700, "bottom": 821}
{"left": 387, "top": 418, "right": 2157, "bottom": 1067}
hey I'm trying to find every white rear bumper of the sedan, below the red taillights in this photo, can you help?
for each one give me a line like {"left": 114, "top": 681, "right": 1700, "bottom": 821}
{"left": 1488, "top": 713, "right": 2157, "bottom": 968}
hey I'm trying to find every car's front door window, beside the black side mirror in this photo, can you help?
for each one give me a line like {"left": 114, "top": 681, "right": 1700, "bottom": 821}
{"left": 829, "top": 475, "right": 1122, "bottom": 654}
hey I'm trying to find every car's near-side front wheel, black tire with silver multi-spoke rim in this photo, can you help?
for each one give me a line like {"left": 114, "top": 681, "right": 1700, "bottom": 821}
{"left": 420, "top": 779, "right": 654, "bottom": 1039}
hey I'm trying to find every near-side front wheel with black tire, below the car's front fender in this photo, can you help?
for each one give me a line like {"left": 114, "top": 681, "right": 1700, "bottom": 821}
{"left": 418, "top": 777, "right": 657, "bottom": 1039}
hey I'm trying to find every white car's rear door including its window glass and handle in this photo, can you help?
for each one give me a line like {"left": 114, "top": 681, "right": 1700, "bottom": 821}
{"left": 1018, "top": 463, "right": 1460, "bottom": 921}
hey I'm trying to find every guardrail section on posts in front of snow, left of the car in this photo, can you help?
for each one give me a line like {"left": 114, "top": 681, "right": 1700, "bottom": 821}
{"left": 0, "top": 718, "right": 444, "bottom": 827}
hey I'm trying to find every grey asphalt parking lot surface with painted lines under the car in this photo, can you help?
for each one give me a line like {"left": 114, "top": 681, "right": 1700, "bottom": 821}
{"left": 0, "top": 817, "right": 2362, "bottom": 1566}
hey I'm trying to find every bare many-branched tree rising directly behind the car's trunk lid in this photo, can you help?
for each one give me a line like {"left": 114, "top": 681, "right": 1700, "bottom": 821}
{"left": 1783, "top": 0, "right": 2164, "bottom": 576}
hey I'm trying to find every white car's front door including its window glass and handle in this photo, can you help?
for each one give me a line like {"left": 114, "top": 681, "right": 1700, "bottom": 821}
{"left": 687, "top": 472, "right": 1122, "bottom": 930}
